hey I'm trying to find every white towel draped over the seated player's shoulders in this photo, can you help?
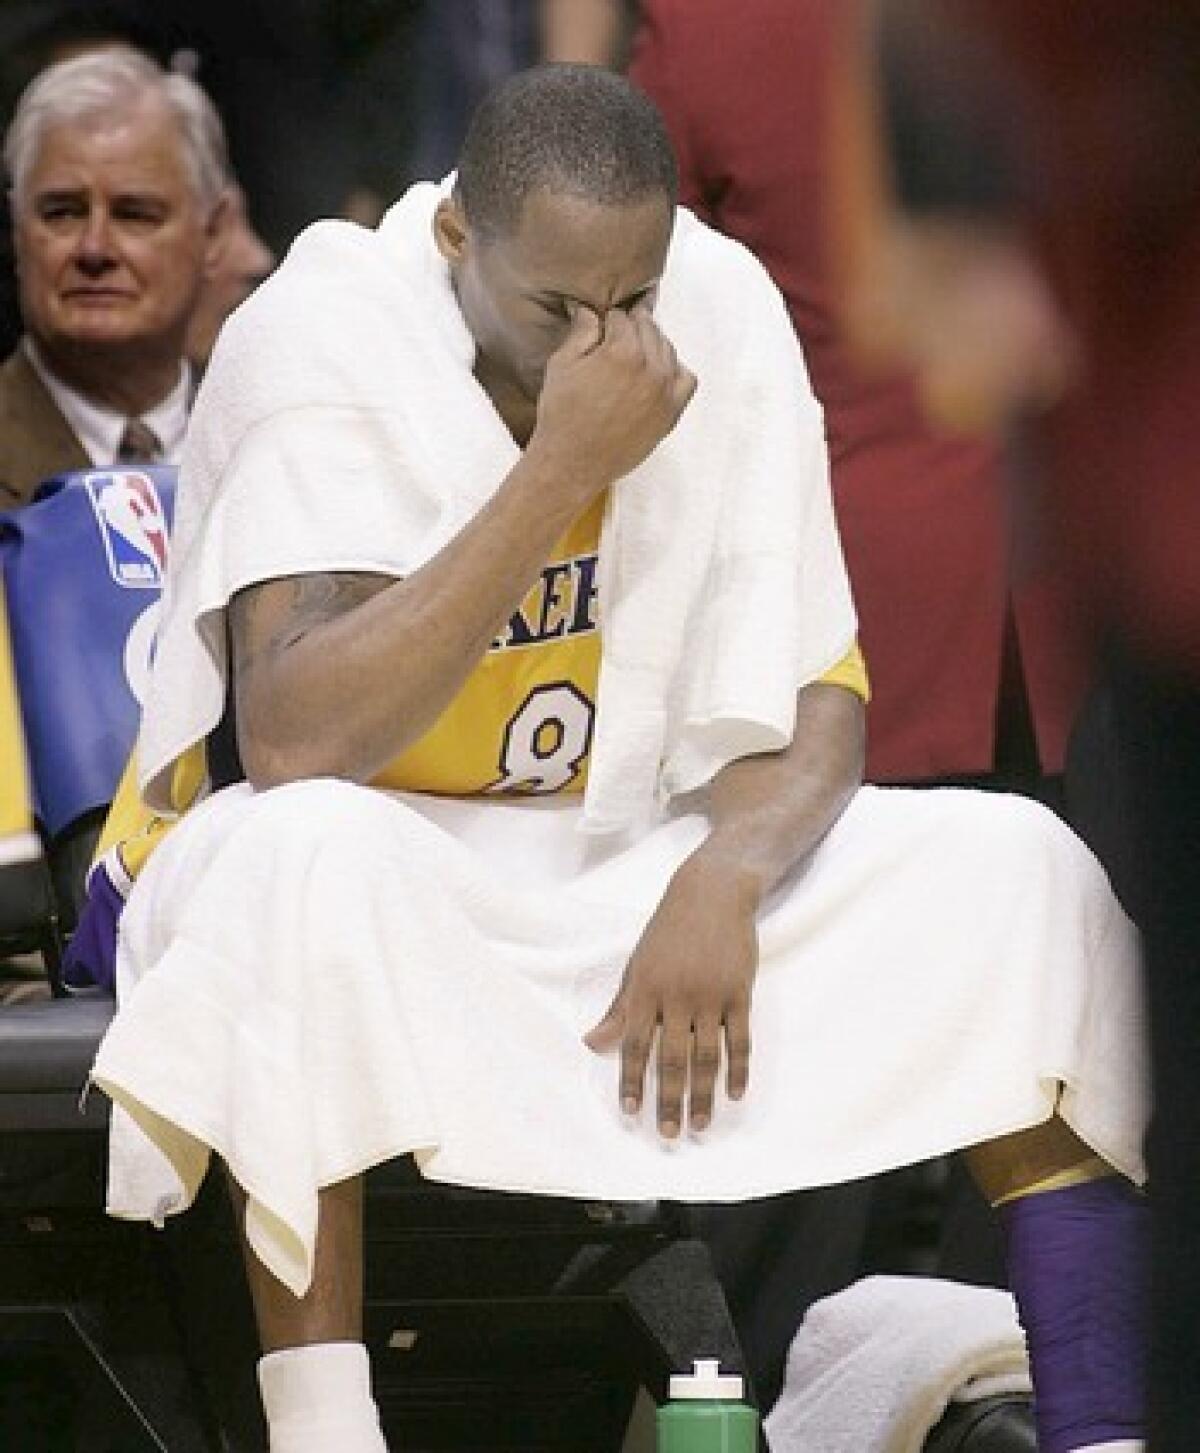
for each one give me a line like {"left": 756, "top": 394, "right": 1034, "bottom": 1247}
{"left": 139, "top": 179, "right": 856, "bottom": 831}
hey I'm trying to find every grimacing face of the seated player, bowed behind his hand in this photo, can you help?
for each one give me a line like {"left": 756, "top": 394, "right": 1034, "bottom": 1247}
{"left": 443, "top": 189, "right": 674, "bottom": 400}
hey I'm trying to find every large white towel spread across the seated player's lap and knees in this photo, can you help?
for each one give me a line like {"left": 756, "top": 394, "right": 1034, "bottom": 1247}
{"left": 94, "top": 780, "right": 1145, "bottom": 1289}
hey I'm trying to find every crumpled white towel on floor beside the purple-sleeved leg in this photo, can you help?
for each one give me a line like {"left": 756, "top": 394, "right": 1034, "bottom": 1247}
{"left": 764, "top": 1276, "right": 1031, "bottom": 1453}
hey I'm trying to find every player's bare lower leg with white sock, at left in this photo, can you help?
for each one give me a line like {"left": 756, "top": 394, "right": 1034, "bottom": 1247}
{"left": 231, "top": 1177, "right": 386, "bottom": 1453}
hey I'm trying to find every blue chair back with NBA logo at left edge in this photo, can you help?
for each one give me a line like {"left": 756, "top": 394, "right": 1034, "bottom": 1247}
{"left": 0, "top": 465, "right": 177, "bottom": 840}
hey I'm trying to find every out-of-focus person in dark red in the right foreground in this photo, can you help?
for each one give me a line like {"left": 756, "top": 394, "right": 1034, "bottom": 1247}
{"left": 837, "top": 0, "right": 1200, "bottom": 1453}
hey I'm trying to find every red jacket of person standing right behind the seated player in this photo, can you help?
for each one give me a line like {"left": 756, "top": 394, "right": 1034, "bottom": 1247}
{"left": 629, "top": 0, "right": 1088, "bottom": 805}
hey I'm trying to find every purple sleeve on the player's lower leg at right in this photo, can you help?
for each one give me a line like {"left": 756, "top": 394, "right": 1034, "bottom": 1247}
{"left": 1000, "top": 1175, "right": 1149, "bottom": 1453}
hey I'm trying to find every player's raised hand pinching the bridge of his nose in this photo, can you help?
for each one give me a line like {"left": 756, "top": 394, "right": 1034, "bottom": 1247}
{"left": 530, "top": 304, "right": 696, "bottom": 497}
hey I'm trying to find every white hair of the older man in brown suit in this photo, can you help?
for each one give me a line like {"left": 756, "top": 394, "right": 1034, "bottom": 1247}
{"left": 4, "top": 45, "right": 232, "bottom": 206}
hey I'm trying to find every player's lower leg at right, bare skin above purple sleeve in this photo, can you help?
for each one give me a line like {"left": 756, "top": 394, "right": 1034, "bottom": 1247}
{"left": 968, "top": 1117, "right": 1149, "bottom": 1453}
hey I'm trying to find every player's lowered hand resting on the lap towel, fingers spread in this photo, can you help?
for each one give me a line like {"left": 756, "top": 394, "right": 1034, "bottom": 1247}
{"left": 585, "top": 859, "right": 758, "bottom": 1139}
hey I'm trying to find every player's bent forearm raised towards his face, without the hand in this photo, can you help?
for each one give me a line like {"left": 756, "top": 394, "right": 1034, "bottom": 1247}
{"left": 238, "top": 449, "right": 594, "bottom": 786}
